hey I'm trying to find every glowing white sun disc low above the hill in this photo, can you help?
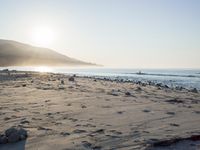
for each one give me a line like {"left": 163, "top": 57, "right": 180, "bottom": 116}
{"left": 31, "top": 26, "right": 55, "bottom": 47}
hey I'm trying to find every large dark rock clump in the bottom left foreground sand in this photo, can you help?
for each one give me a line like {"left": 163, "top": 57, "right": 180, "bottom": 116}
{"left": 0, "top": 127, "right": 28, "bottom": 144}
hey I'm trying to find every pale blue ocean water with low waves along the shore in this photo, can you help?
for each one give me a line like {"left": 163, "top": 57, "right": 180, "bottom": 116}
{"left": 0, "top": 67, "right": 200, "bottom": 90}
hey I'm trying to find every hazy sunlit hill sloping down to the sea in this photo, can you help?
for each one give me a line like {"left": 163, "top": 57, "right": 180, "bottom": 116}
{"left": 0, "top": 40, "right": 95, "bottom": 67}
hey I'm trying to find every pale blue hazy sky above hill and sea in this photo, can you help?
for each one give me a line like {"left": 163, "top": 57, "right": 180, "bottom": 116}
{"left": 0, "top": 0, "right": 200, "bottom": 68}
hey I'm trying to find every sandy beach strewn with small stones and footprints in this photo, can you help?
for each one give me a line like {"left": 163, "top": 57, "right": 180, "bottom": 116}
{"left": 0, "top": 71, "right": 200, "bottom": 150}
